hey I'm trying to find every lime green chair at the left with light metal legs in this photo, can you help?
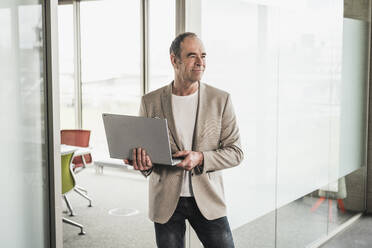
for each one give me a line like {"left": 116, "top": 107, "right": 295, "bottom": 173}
{"left": 61, "top": 152, "right": 85, "bottom": 235}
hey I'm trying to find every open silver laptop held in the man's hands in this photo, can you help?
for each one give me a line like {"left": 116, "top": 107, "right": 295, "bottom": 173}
{"left": 102, "top": 113, "right": 182, "bottom": 165}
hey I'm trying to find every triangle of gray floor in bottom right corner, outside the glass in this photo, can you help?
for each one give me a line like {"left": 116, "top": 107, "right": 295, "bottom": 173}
{"left": 321, "top": 215, "right": 372, "bottom": 248}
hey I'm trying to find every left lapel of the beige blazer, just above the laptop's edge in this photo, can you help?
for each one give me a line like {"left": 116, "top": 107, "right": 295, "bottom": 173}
{"left": 161, "top": 82, "right": 183, "bottom": 151}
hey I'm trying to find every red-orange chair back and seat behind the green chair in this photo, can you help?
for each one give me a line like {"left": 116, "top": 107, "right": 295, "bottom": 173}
{"left": 61, "top": 129, "right": 92, "bottom": 171}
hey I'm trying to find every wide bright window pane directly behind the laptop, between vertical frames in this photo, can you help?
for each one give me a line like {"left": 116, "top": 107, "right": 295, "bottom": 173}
{"left": 80, "top": 0, "right": 141, "bottom": 158}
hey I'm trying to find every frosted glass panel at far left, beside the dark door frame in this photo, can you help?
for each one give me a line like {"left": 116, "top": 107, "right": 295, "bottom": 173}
{"left": 0, "top": 0, "right": 49, "bottom": 248}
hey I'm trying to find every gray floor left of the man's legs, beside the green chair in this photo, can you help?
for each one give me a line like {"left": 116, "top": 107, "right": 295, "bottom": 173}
{"left": 63, "top": 168, "right": 155, "bottom": 248}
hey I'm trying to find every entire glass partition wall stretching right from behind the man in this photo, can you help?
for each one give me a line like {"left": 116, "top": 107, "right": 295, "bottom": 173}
{"left": 201, "top": 0, "right": 369, "bottom": 248}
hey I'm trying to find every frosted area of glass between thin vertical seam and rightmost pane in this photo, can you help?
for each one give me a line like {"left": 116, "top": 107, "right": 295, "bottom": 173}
{"left": 277, "top": 0, "right": 343, "bottom": 207}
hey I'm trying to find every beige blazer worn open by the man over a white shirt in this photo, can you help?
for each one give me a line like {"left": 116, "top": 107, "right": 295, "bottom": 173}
{"left": 140, "top": 83, "right": 243, "bottom": 223}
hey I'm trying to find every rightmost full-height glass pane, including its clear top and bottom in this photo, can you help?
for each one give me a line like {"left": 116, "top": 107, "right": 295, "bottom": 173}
{"left": 325, "top": 1, "right": 370, "bottom": 232}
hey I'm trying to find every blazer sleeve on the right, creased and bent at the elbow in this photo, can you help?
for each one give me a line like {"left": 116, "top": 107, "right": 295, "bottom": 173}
{"left": 200, "top": 95, "right": 244, "bottom": 173}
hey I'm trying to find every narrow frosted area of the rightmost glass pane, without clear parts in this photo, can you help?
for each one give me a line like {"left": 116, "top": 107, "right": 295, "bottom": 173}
{"left": 338, "top": 18, "right": 368, "bottom": 178}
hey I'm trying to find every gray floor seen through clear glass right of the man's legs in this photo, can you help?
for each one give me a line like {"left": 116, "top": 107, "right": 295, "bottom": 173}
{"left": 233, "top": 196, "right": 353, "bottom": 248}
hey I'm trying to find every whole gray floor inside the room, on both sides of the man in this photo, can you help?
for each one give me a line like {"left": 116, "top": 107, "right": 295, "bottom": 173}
{"left": 63, "top": 167, "right": 358, "bottom": 248}
